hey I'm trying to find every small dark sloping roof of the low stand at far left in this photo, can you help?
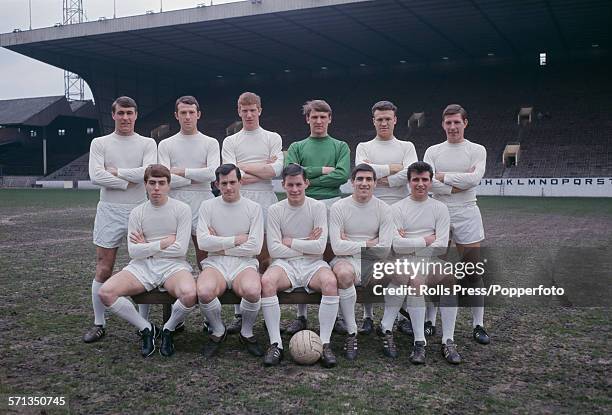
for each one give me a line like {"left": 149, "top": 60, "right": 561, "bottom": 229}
{"left": 0, "top": 95, "right": 95, "bottom": 127}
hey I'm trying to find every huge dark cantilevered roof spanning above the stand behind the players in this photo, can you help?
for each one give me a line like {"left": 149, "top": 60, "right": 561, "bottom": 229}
{"left": 0, "top": 0, "right": 612, "bottom": 79}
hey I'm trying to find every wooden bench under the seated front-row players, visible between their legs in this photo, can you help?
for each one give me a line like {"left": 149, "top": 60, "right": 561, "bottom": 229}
{"left": 132, "top": 286, "right": 384, "bottom": 323}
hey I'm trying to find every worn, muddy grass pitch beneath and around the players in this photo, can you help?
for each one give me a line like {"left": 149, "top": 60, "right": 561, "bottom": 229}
{"left": 0, "top": 190, "right": 612, "bottom": 414}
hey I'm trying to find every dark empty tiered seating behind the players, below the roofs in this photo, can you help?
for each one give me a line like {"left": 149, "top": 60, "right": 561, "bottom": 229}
{"left": 5, "top": 63, "right": 612, "bottom": 180}
